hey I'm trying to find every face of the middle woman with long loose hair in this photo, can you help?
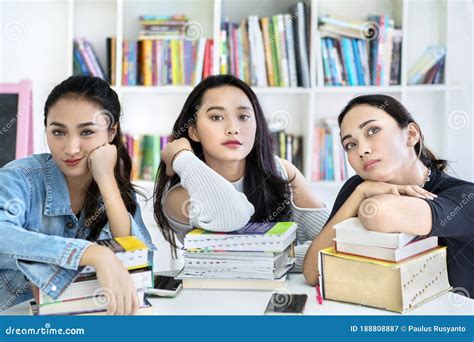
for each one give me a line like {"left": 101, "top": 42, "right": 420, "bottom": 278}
{"left": 189, "top": 86, "right": 257, "bottom": 161}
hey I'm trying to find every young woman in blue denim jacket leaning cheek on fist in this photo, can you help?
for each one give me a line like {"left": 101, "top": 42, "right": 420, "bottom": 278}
{"left": 0, "top": 76, "right": 153, "bottom": 314}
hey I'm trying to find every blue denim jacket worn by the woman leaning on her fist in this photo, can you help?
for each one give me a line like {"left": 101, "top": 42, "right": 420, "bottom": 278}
{"left": 0, "top": 153, "right": 155, "bottom": 311}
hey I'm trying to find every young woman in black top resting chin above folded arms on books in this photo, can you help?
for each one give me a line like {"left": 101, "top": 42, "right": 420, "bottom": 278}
{"left": 303, "top": 95, "right": 474, "bottom": 297}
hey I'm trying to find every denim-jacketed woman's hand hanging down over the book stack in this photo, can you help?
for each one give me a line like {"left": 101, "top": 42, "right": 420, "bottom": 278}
{"left": 81, "top": 244, "right": 139, "bottom": 315}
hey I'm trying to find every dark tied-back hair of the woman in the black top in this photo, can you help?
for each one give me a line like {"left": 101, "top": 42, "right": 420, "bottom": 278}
{"left": 337, "top": 94, "right": 448, "bottom": 171}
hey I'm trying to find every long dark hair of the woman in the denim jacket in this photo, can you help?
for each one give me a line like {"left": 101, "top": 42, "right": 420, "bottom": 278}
{"left": 44, "top": 76, "right": 142, "bottom": 240}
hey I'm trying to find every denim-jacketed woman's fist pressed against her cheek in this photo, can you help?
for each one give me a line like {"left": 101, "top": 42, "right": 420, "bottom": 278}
{"left": 88, "top": 143, "right": 117, "bottom": 184}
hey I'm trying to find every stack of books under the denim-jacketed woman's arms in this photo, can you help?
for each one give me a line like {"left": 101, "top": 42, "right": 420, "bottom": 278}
{"left": 30, "top": 236, "right": 153, "bottom": 315}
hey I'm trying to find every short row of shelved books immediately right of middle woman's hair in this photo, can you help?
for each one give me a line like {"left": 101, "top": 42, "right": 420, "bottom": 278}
{"left": 271, "top": 131, "right": 303, "bottom": 171}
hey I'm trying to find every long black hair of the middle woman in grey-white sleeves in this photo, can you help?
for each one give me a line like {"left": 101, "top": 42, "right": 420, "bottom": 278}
{"left": 153, "top": 75, "right": 290, "bottom": 247}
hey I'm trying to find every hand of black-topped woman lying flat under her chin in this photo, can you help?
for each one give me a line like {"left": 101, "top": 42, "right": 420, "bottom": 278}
{"left": 357, "top": 181, "right": 438, "bottom": 199}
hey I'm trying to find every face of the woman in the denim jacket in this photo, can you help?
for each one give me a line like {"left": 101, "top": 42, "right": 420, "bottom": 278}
{"left": 46, "top": 98, "right": 114, "bottom": 178}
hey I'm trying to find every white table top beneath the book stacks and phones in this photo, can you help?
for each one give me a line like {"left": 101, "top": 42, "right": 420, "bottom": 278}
{"left": 2, "top": 274, "right": 474, "bottom": 316}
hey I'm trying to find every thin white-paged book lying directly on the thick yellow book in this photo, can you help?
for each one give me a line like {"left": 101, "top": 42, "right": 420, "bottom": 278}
{"left": 336, "top": 236, "right": 438, "bottom": 262}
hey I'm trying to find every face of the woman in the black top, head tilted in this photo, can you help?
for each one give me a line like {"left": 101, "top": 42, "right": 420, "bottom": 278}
{"left": 341, "top": 105, "right": 416, "bottom": 182}
